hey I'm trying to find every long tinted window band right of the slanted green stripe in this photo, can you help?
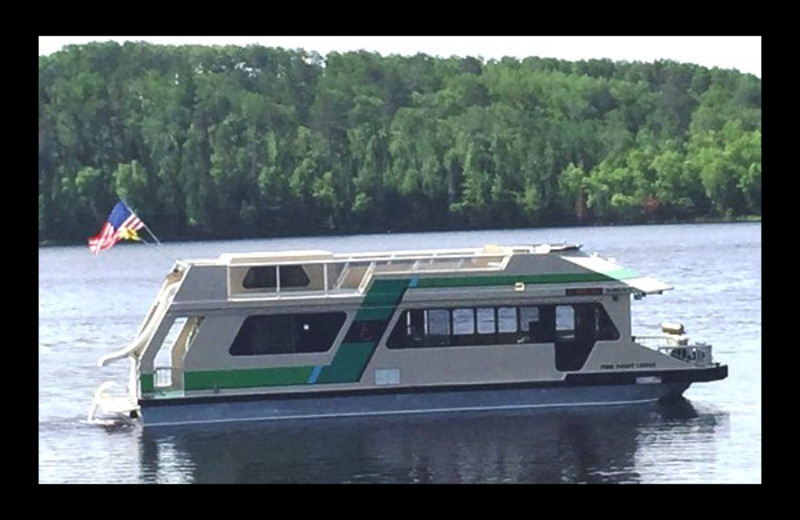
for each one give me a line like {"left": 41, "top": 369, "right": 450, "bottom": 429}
{"left": 387, "top": 303, "right": 619, "bottom": 348}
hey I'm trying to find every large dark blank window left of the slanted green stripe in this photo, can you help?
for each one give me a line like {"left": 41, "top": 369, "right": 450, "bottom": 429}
{"left": 229, "top": 312, "right": 345, "bottom": 356}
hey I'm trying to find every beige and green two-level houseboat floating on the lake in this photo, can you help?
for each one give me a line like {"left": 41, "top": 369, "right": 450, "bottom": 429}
{"left": 89, "top": 244, "right": 728, "bottom": 427}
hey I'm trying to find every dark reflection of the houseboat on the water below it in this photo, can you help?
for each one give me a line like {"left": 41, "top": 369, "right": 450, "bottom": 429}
{"left": 138, "top": 399, "right": 727, "bottom": 483}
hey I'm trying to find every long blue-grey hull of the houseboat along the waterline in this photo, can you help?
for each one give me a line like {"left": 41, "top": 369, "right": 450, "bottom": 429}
{"left": 141, "top": 382, "right": 691, "bottom": 428}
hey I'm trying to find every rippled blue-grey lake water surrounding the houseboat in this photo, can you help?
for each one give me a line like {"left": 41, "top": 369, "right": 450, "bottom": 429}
{"left": 39, "top": 223, "right": 761, "bottom": 483}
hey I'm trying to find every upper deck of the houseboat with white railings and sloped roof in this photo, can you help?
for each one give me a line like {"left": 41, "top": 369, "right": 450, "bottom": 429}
{"left": 166, "top": 244, "right": 671, "bottom": 306}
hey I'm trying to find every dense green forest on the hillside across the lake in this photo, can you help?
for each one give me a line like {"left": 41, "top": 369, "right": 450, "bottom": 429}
{"left": 38, "top": 42, "right": 761, "bottom": 243}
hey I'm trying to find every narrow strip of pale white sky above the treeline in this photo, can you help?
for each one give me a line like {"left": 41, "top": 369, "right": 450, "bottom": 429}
{"left": 39, "top": 36, "right": 761, "bottom": 78}
